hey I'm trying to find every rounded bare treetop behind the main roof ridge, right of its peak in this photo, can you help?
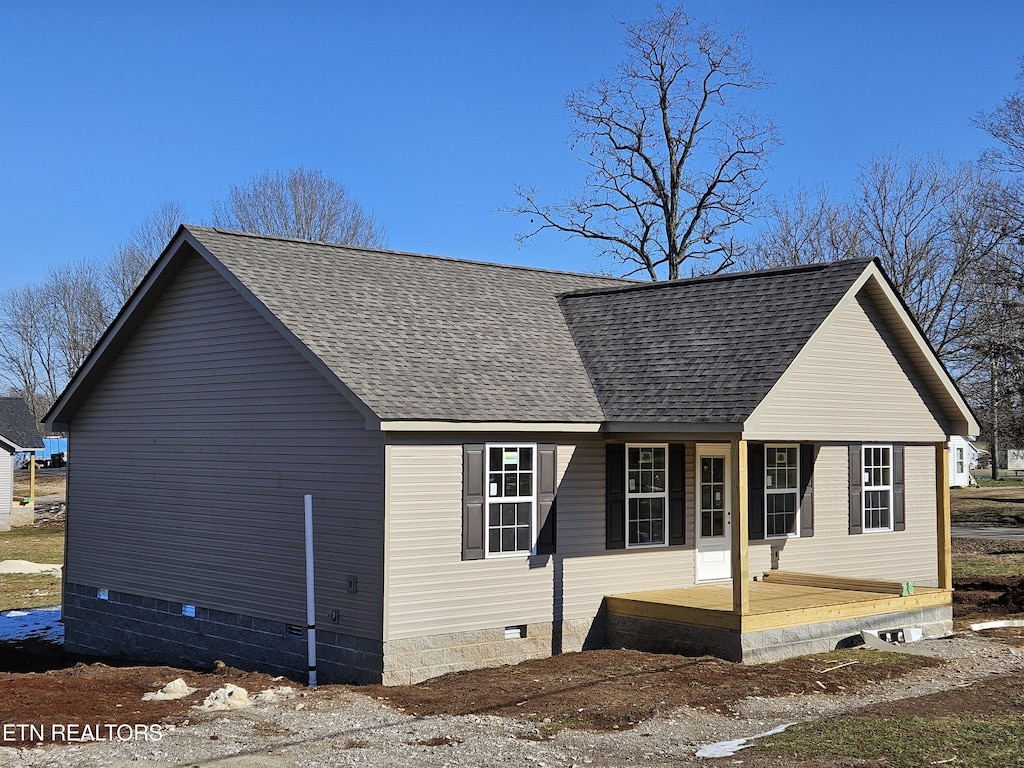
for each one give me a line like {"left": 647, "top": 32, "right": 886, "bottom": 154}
{"left": 213, "top": 166, "right": 387, "bottom": 248}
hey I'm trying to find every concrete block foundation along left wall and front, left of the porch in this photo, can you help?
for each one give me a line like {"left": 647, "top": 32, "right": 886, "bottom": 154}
{"left": 63, "top": 583, "right": 604, "bottom": 685}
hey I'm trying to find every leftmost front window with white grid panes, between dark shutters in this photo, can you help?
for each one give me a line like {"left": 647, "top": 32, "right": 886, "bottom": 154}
{"left": 486, "top": 444, "right": 537, "bottom": 555}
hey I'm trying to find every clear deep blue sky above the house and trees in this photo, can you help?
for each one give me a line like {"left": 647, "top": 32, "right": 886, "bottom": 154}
{"left": 0, "top": 0, "right": 1024, "bottom": 290}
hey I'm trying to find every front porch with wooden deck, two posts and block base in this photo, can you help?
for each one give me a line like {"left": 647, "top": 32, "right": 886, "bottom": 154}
{"left": 605, "top": 440, "right": 952, "bottom": 663}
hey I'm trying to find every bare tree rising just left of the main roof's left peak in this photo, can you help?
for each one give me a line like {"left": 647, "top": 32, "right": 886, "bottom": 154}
{"left": 102, "top": 203, "right": 185, "bottom": 312}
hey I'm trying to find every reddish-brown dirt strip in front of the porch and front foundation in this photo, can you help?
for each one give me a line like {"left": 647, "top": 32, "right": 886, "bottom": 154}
{"left": 360, "top": 650, "right": 939, "bottom": 731}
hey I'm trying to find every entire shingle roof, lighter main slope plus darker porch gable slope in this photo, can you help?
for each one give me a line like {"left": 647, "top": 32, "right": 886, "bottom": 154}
{"left": 187, "top": 227, "right": 869, "bottom": 423}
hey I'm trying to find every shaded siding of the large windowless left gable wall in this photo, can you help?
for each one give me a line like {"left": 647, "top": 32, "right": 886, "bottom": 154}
{"left": 67, "top": 258, "right": 383, "bottom": 637}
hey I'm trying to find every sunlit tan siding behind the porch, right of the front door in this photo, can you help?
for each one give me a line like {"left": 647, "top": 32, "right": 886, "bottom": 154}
{"left": 750, "top": 445, "right": 938, "bottom": 586}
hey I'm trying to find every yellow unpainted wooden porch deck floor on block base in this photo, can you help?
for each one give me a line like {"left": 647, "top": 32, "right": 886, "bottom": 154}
{"left": 605, "top": 581, "right": 952, "bottom": 633}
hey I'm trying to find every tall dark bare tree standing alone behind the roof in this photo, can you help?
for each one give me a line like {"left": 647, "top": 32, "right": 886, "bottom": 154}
{"left": 505, "top": 5, "right": 779, "bottom": 280}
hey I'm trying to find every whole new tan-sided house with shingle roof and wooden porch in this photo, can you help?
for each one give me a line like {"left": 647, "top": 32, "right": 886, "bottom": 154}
{"left": 45, "top": 227, "right": 977, "bottom": 683}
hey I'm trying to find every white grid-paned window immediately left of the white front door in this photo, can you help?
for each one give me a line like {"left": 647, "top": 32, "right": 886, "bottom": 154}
{"left": 626, "top": 445, "right": 669, "bottom": 547}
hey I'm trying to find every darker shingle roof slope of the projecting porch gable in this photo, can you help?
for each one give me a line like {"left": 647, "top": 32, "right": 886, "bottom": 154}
{"left": 561, "top": 259, "right": 870, "bottom": 424}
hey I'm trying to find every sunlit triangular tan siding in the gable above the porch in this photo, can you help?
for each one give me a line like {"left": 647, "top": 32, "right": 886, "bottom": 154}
{"left": 744, "top": 292, "right": 948, "bottom": 441}
